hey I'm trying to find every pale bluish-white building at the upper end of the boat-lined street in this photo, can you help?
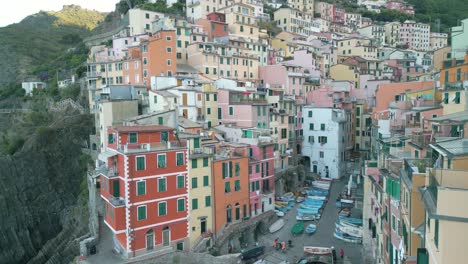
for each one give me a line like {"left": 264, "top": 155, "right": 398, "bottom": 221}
{"left": 302, "top": 106, "right": 347, "bottom": 179}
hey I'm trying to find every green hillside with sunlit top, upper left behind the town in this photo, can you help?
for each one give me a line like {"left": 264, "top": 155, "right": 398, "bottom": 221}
{"left": 0, "top": 5, "right": 104, "bottom": 85}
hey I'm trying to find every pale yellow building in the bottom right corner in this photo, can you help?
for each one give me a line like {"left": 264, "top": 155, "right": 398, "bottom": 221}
{"left": 418, "top": 151, "right": 468, "bottom": 264}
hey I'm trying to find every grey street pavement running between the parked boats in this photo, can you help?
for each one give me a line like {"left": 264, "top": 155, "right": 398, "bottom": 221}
{"left": 259, "top": 174, "right": 362, "bottom": 264}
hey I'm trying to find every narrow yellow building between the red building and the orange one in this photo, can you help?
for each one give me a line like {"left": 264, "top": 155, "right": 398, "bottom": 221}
{"left": 186, "top": 135, "right": 214, "bottom": 251}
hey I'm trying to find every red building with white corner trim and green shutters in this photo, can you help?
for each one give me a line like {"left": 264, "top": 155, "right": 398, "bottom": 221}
{"left": 99, "top": 126, "right": 188, "bottom": 257}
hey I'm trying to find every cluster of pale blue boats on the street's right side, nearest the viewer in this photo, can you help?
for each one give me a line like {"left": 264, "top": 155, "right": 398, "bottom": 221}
{"left": 334, "top": 216, "right": 362, "bottom": 244}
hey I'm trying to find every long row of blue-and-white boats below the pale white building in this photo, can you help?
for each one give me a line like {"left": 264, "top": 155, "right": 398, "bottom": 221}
{"left": 296, "top": 180, "right": 331, "bottom": 221}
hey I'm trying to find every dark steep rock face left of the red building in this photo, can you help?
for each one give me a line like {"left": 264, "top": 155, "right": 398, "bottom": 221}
{"left": 0, "top": 112, "right": 93, "bottom": 264}
